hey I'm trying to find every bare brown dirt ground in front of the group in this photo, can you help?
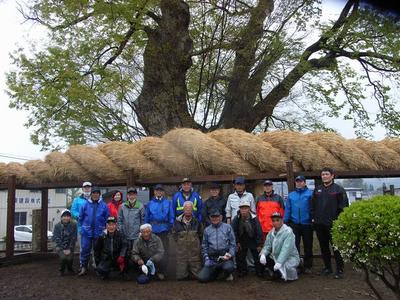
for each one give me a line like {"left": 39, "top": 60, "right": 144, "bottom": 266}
{"left": 0, "top": 258, "right": 391, "bottom": 300}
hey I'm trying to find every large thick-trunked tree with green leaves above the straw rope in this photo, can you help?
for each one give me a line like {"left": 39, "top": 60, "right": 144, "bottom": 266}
{"left": 8, "top": 0, "right": 400, "bottom": 148}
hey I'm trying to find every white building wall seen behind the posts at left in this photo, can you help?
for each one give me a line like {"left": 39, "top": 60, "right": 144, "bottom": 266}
{"left": 0, "top": 189, "right": 67, "bottom": 239}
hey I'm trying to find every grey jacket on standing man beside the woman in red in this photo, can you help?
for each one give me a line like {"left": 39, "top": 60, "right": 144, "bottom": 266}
{"left": 118, "top": 199, "right": 144, "bottom": 240}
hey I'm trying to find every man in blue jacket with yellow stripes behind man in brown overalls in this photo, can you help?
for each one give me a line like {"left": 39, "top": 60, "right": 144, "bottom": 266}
{"left": 172, "top": 177, "right": 203, "bottom": 222}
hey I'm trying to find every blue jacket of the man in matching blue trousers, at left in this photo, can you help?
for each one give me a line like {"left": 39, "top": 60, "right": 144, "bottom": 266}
{"left": 79, "top": 199, "right": 110, "bottom": 238}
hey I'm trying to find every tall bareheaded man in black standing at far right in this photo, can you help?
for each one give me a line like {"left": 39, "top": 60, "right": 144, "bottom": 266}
{"left": 311, "top": 168, "right": 349, "bottom": 279}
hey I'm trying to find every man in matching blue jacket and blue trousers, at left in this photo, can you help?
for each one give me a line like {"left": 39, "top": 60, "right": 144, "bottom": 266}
{"left": 78, "top": 187, "right": 110, "bottom": 276}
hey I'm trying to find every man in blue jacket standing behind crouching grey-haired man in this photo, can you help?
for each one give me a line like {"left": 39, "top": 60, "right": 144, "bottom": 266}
{"left": 144, "top": 184, "right": 174, "bottom": 269}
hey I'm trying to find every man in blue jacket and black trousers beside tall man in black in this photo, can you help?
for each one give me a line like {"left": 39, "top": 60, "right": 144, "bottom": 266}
{"left": 284, "top": 176, "right": 313, "bottom": 274}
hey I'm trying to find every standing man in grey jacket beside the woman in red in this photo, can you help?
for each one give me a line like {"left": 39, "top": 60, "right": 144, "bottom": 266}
{"left": 118, "top": 187, "right": 144, "bottom": 252}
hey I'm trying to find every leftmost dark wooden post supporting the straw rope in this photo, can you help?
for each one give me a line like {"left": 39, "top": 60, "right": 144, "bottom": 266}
{"left": 6, "top": 175, "right": 17, "bottom": 257}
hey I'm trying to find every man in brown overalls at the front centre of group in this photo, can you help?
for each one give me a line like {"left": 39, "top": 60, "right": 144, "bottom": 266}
{"left": 172, "top": 201, "right": 202, "bottom": 280}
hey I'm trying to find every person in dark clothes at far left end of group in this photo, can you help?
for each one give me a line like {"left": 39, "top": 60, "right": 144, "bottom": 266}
{"left": 53, "top": 209, "right": 77, "bottom": 276}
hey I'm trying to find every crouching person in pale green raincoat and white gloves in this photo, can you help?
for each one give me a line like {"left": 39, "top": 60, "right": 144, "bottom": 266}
{"left": 260, "top": 212, "right": 300, "bottom": 281}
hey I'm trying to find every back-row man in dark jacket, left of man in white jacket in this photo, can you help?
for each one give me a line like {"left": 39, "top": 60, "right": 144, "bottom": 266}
{"left": 201, "top": 182, "right": 226, "bottom": 226}
